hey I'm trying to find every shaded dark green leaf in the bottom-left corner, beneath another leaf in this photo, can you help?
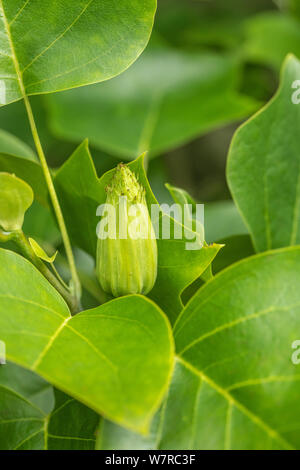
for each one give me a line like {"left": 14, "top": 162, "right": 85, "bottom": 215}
{"left": 0, "top": 363, "right": 99, "bottom": 450}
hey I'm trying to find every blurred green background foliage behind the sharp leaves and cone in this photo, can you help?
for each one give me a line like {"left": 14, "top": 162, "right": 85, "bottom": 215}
{"left": 0, "top": 0, "right": 300, "bottom": 241}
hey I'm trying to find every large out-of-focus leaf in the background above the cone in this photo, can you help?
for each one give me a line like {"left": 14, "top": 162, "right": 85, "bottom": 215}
{"left": 47, "top": 49, "right": 257, "bottom": 160}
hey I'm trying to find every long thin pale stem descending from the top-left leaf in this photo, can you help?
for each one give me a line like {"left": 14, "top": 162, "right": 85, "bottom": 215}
{"left": 24, "top": 93, "right": 81, "bottom": 305}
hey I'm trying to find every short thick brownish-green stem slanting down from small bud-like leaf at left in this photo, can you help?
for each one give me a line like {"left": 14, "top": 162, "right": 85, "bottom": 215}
{"left": 10, "top": 230, "right": 78, "bottom": 313}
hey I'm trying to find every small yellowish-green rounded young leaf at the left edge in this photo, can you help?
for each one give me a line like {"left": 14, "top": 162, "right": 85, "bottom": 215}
{"left": 0, "top": 173, "right": 33, "bottom": 232}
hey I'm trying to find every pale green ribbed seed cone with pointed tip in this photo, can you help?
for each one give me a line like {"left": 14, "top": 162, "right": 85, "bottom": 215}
{"left": 96, "top": 164, "right": 157, "bottom": 297}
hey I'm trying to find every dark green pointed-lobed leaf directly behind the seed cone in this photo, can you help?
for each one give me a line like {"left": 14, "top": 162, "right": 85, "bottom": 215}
{"left": 55, "top": 141, "right": 221, "bottom": 321}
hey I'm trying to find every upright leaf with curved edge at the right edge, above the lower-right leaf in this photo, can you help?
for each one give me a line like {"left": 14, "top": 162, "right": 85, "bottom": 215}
{"left": 227, "top": 56, "right": 300, "bottom": 251}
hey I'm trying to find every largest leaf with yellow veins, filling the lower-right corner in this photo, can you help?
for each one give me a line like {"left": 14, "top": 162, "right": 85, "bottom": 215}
{"left": 98, "top": 247, "right": 300, "bottom": 450}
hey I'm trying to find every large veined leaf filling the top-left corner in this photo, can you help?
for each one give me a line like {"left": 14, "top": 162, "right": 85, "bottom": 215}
{"left": 0, "top": 0, "right": 156, "bottom": 104}
